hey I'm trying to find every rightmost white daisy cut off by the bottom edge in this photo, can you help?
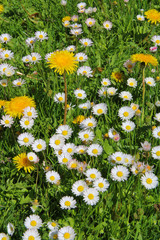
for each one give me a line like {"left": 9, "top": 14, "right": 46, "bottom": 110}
{"left": 58, "top": 226, "right": 76, "bottom": 240}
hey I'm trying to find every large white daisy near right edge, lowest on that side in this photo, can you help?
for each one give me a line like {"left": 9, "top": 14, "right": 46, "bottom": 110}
{"left": 141, "top": 172, "right": 158, "bottom": 189}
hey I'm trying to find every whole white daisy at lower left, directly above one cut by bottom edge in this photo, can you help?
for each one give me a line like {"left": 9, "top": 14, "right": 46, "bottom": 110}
{"left": 24, "top": 214, "right": 42, "bottom": 230}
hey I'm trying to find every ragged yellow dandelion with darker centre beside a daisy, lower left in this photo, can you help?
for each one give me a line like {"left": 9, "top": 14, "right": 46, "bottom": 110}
{"left": 13, "top": 153, "right": 34, "bottom": 173}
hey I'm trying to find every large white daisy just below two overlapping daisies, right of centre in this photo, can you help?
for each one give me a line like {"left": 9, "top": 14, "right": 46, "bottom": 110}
{"left": 111, "top": 165, "right": 129, "bottom": 182}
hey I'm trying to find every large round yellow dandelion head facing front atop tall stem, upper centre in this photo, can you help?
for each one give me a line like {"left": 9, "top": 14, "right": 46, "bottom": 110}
{"left": 48, "top": 50, "right": 78, "bottom": 75}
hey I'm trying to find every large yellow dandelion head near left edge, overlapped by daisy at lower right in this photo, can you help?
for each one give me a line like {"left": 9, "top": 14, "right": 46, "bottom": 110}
{"left": 4, "top": 96, "right": 36, "bottom": 118}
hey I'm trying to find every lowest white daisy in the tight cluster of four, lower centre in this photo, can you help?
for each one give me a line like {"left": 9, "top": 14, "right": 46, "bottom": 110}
{"left": 83, "top": 188, "right": 99, "bottom": 206}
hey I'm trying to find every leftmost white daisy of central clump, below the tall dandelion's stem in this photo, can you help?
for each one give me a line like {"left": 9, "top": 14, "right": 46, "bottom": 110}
{"left": 49, "top": 134, "right": 65, "bottom": 150}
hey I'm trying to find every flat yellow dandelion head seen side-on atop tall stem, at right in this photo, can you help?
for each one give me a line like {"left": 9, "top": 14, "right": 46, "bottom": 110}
{"left": 131, "top": 53, "right": 158, "bottom": 66}
